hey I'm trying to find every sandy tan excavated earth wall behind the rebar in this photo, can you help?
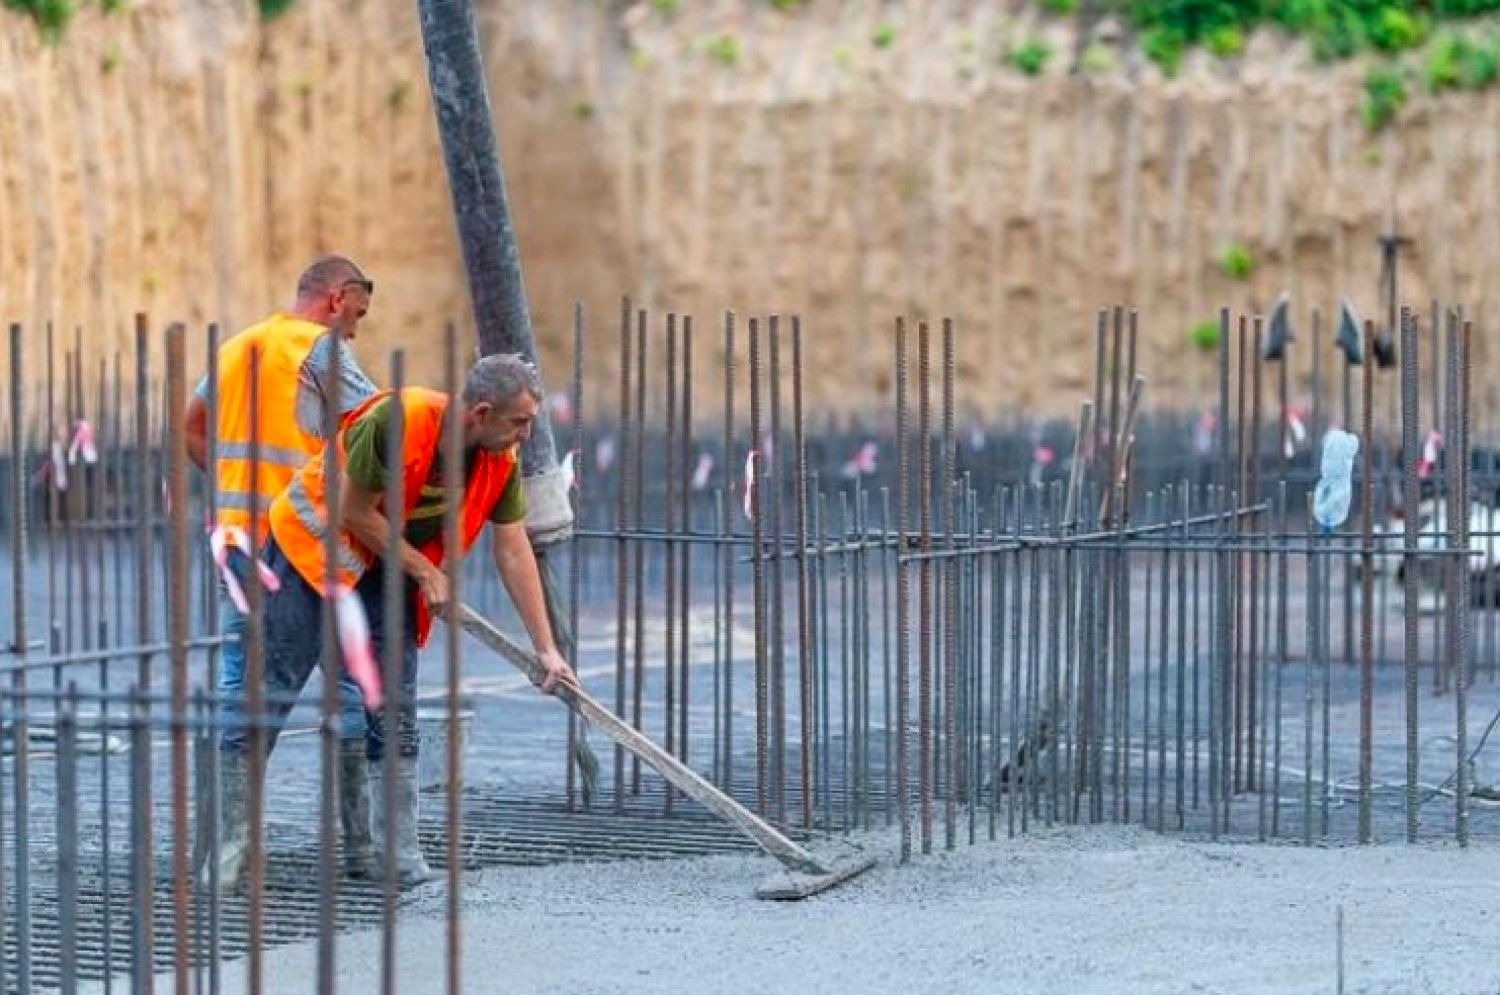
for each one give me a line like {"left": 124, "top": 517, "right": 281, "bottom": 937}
{"left": 0, "top": 0, "right": 1500, "bottom": 417}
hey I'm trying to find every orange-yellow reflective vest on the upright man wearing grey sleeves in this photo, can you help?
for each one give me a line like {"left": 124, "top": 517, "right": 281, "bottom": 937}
{"left": 213, "top": 314, "right": 327, "bottom": 546}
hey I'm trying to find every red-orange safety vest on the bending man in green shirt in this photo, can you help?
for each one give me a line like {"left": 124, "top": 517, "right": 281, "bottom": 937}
{"left": 270, "top": 387, "right": 516, "bottom": 647}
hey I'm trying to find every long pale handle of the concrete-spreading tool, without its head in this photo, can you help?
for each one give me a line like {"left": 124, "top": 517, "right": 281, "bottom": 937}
{"left": 459, "top": 605, "right": 831, "bottom": 873}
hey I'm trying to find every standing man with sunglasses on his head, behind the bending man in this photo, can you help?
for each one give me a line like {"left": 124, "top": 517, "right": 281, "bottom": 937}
{"left": 186, "top": 255, "right": 375, "bottom": 890}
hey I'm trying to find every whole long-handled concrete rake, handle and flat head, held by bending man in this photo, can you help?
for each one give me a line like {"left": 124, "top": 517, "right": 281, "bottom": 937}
{"left": 459, "top": 605, "right": 875, "bottom": 900}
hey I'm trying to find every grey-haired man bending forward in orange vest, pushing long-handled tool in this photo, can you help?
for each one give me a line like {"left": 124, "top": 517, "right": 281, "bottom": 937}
{"left": 235, "top": 356, "right": 578, "bottom": 887}
